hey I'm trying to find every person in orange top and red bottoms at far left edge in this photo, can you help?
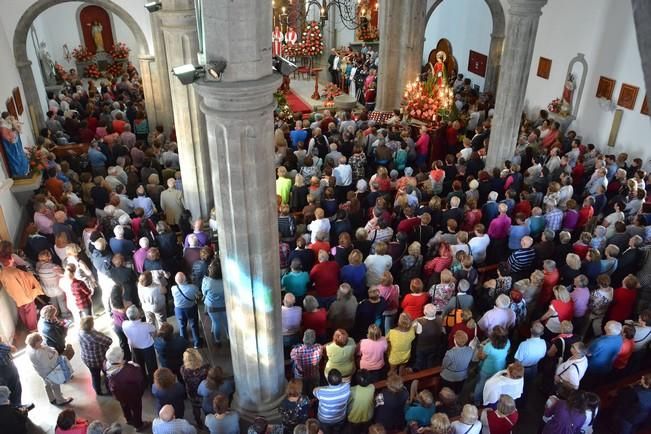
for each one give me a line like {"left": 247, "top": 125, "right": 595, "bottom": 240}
{"left": 0, "top": 259, "right": 44, "bottom": 331}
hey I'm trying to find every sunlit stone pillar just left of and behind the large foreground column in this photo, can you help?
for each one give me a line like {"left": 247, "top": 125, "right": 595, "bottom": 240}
{"left": 158, "top": 0, "right": 213, "bottom": 218}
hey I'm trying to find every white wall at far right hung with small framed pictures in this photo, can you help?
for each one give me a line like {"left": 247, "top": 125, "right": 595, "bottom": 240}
{"left": 524, "top": 0, "right": 651, "bottom": 159}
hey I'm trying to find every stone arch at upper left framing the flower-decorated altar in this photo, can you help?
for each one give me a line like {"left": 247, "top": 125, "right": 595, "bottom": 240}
{"left": 13, "top": 0, "right": 154, "bottom": 132}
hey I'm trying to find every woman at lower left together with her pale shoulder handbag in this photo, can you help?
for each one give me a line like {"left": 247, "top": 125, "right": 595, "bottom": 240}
{"left": 25, "top": 333, "right": 72, "bottom": 406}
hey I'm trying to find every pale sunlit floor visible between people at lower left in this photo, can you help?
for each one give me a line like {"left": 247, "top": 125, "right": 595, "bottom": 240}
{"left": 17, "top": 315, "right": 232, "bottom": 434}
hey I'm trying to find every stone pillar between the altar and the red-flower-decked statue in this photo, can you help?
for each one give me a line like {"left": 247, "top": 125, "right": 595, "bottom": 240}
{"left": 376, "top": 0, "right": 427, "bottom": 111}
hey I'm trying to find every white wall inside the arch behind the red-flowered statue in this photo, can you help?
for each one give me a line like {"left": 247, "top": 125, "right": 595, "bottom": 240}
{"left": 423, "top": 0, "right": 493, "bottom": 88}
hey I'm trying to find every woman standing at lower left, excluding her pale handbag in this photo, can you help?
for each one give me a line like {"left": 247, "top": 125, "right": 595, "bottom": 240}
{"left": 25, "top": 333, "right": 72, "bottom": 406}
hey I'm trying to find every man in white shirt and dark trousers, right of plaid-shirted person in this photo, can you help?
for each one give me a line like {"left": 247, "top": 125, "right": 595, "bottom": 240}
{"left": 122, "top": 305, "right": 158, "bottom": 384}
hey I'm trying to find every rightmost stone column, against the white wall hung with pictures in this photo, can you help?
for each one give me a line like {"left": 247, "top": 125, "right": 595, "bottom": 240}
{"left": 486, "top": 0, "right": 547, "bottom": 169}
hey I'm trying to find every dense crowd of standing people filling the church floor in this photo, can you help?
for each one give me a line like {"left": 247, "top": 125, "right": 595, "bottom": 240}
{"left": 0, "top": 47, "right": 651, "bottom": 434}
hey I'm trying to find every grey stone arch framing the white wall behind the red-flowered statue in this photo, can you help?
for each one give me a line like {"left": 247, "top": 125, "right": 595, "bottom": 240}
{"left": 425, "top": 0, "right": 506, "bottom": 95}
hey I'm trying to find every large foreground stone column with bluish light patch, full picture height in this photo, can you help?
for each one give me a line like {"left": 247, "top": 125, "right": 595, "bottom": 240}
{"left": 195, "top": 0, "right": 285, "bottom": 420}
